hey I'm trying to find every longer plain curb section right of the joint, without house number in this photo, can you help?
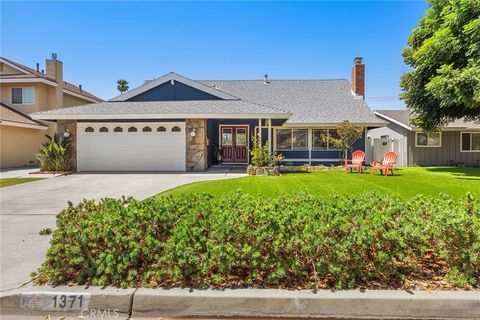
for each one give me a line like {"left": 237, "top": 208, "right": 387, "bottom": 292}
{"left": 132, "top": 288, "right": 480, "bottom": 319}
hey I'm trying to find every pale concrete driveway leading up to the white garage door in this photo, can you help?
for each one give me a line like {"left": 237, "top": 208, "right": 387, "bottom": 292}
{"left": 0, "top": 168, "right": 245, "bottom": 291}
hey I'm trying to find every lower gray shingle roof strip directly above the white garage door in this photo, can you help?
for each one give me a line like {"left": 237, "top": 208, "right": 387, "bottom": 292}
{"left": 32, "top": 100, "right": 290, "bottom": 119}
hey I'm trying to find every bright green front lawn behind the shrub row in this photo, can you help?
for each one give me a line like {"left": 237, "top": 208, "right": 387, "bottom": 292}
{"left": 159, "top": 167, "right": 480, "bottom": 198}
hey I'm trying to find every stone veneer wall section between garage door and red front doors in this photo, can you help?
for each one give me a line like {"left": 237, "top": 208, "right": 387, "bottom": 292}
{"left": 185, "top": 119, "right": 208, "bottom": 171}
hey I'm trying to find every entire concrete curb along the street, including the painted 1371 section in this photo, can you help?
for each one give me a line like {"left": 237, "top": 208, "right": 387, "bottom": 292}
{"left": 0, "top": 286, "right": 480, "bottom": 319}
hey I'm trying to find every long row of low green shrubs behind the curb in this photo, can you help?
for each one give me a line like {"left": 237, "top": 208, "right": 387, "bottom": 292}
{"left": 36, "top": 192, "right": 480, "bottom": 289}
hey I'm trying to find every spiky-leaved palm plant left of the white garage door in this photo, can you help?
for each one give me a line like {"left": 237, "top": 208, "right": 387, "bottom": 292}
{"left": 35, "top": 134, "right": 73, "bottom": 171}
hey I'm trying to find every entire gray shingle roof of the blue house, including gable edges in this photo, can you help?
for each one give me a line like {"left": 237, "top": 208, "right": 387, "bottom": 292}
{"left": 34, "top": 73, "right": 385, "bottom": 125}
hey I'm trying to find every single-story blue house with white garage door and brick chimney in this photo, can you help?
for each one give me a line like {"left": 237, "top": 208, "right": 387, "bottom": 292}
{"left": 32, "top": 58, "right": 385, "bottom": 171}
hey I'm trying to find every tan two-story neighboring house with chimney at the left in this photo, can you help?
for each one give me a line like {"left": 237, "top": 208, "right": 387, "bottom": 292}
{"left": 0, "top": 55, "right": 102, "bottom": 168}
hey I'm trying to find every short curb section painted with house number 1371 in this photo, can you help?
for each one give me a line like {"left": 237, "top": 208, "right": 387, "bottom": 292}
{"left": 0, "top": 286, "right": 135, "bottom": 319}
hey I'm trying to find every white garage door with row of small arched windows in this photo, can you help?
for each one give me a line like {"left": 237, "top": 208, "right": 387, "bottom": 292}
{"left": 77, "top": 122, "right": 186, "bottom": 171}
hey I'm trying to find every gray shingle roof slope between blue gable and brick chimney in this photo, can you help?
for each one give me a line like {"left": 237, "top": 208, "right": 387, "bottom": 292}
{"left": 199, "top": 79, "right": 385, "bottom": 124}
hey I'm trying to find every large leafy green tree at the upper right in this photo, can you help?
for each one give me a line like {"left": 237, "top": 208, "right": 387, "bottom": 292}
{"left": 400, "top": 0, "right": 480, "bottom": 130}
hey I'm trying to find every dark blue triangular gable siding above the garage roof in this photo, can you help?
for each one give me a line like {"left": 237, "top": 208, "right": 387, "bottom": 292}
{"left": 127, "top": 81, "right": 220, "bottom": 101}
